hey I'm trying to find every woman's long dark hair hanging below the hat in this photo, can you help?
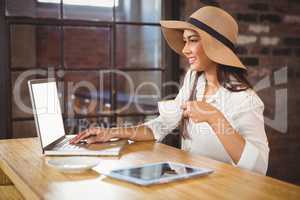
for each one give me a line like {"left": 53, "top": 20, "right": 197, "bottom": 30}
{"left": 180, "top": 64, "right": 253, "bottom": 138}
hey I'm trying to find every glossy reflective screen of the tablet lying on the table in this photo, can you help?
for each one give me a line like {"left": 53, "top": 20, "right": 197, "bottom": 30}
{"left": 113, "top": 163, "right": 202, "bottom": 181}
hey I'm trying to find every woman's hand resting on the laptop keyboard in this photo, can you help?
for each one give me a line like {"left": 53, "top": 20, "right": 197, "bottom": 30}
{"left": 70, "top": 127, "right": 115, "bottom": 144}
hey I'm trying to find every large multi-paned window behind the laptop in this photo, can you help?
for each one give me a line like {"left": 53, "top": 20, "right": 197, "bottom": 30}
{"left": 6, "top": 0, "right": 166, "bottom": 137}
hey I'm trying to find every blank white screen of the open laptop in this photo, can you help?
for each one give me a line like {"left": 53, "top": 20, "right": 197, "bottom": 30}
{"left": 31, "top": 82, "right": 65, "bottom": 147}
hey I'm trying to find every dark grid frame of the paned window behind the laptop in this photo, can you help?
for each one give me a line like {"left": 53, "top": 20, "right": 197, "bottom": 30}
{"left": 3, "top": 0, "right": 179, "bottom": 138}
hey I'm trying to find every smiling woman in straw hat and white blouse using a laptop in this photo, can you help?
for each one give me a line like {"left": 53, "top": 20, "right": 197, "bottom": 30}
{"left": 71, "top": 6, "right": 269, "bottom": 174}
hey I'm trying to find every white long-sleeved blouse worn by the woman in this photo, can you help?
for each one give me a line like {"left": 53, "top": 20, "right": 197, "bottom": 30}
{"left": 144, "top": 70, "right": 269, "bottom": 174}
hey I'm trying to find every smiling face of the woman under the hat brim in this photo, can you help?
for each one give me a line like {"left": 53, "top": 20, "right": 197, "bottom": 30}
{"left": 182, "top": 30, "right": 213, "bottom": 71}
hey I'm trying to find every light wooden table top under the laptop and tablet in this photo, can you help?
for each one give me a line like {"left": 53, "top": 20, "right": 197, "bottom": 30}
{"left": 0, "top": 138, "right": 300, "bottom": 200}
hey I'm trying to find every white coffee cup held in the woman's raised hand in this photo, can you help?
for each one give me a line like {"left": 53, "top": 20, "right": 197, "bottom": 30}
{"left": 158, "top": 100, "right": 182, "bottom": 119}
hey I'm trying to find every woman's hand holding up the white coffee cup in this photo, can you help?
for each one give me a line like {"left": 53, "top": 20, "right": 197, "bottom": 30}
{"left": 181, "top": 101, "right": 221, "bottom": 123}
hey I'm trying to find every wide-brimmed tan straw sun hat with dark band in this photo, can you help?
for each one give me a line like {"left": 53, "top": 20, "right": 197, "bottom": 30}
{"left": 160, "top": 6, "right": 246, "bottom": 69}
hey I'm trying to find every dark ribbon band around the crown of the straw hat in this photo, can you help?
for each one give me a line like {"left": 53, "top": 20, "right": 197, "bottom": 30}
{"left": 188, "top": 17, "right": 235, "bottom": 52}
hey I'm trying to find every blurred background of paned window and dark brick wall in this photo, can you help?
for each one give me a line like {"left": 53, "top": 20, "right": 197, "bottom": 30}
{"left": 0, "top": 0, "right": 300, "bottom": 184}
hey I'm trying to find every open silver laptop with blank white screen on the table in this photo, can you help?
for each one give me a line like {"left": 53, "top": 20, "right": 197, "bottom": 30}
{"left": 28, "top": 79, "right": 128, "bottom": 156}
